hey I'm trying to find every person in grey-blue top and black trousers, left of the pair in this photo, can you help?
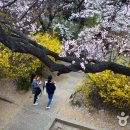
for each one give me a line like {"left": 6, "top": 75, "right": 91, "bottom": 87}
{"left": 31, "top": 73, "right": 41, "bottom": 105}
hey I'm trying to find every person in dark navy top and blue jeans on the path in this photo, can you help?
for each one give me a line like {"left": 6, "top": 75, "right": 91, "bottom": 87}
{"left": 43, "top": 75, "right": 56, "bottom": 109}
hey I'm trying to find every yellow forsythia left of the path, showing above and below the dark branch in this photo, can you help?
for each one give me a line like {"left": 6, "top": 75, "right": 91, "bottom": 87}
{"left": 0, "top": 32, "right": 61, "bottom": 78}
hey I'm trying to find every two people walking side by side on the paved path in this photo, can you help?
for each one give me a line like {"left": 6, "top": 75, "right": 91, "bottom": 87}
{"left": 31, "top": 74, "right": 56, "bottom": 109}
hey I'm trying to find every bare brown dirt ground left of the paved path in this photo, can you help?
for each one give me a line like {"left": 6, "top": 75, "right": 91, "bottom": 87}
{"left": 0, "top": 79, "right": 29, "bottom": 130}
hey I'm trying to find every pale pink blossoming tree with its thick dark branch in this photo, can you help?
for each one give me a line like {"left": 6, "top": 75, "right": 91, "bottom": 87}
{"left": 0, "top": 0, "right": 130, "bottom": 76}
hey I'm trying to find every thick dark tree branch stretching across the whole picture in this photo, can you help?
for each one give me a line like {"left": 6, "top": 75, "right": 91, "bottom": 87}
{"left": 0, "top": 24, "right": 130, "bottom": 76}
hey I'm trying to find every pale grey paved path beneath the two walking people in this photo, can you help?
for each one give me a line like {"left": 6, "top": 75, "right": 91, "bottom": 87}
{"left": 4, "top": 73, "right": 94, "bottom": 130}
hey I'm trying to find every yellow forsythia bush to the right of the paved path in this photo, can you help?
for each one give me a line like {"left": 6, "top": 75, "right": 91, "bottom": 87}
{"left": 80, "top": 70, "right": 130, "bottom": 110}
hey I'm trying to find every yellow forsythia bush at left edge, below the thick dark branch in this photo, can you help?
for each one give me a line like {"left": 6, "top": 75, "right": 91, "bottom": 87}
{"left": 0, "top": 43, "right": 41, "bottom": 78}
